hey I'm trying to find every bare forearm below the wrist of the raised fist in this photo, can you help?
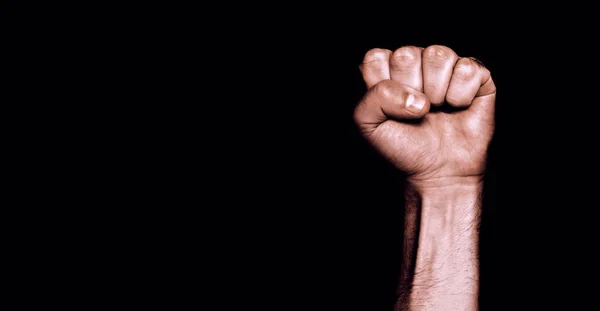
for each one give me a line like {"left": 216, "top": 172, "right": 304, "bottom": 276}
{"left": 400, "top": 178, "right": 482, "bottom": 310}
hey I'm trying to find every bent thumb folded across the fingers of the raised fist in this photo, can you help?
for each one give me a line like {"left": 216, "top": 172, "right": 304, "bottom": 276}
{"left": 354, "top": 80, "right": 430, "bottom": 129}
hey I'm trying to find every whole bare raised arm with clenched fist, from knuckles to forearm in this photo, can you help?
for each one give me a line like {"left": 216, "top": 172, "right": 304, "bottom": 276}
{"left": 354, "top": 45, "right": 496, "bottom": 311}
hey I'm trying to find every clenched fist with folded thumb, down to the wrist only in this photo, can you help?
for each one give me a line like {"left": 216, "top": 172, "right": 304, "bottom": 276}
{"left": 354, "top": 45, "right": 496, "bottom": 182}
